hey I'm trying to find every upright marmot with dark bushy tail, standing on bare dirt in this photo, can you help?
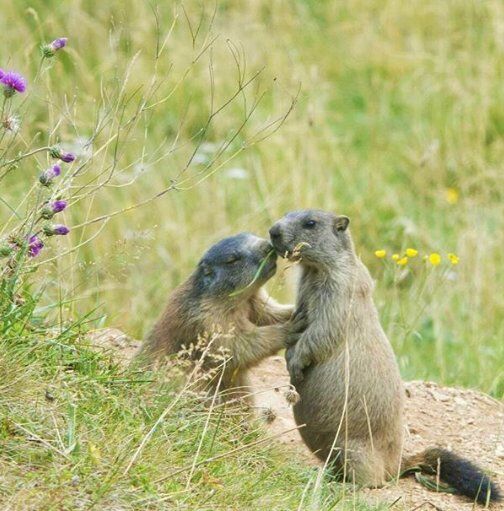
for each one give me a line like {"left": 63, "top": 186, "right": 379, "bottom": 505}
{"left": 270, "top": 210, "right": 499, "bottom": 502}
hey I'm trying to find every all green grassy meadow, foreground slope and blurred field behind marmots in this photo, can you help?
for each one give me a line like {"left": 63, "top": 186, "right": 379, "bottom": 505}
{"left": 0, "top": 0, "right": 504, "bottom": 511}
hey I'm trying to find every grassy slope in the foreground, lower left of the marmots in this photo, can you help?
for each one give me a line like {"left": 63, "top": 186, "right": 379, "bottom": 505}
{"left": 0, "top": 323, "right": 385, "bottom": 511}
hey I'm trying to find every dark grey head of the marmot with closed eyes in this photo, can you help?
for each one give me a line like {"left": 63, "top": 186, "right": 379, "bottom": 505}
{"left": 194, "top": 233, "right": 276, "bottom": 300}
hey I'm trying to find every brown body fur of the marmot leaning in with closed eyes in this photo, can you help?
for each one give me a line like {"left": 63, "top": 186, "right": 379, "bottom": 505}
{"left": 137, "top": 235, "right": 293, "bottom": 406}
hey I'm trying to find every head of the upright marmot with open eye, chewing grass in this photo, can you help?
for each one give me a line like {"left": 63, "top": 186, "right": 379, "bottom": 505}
{"left": 269, "top": 209, "right": 352, "bottom": 265}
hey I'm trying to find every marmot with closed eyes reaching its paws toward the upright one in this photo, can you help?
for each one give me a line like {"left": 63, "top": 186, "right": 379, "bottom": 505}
{"left": 135, "top": 233, "right": 293, "bottom": 404}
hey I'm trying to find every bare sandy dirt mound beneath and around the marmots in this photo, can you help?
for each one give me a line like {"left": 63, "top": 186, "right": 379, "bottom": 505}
{"left": 90, "top": 329, "right": 504, "bottom": 511}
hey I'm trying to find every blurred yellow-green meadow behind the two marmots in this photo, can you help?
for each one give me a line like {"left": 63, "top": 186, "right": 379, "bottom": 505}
{"left": 0, "top": 0, "right": 504, "bottom": 397}
